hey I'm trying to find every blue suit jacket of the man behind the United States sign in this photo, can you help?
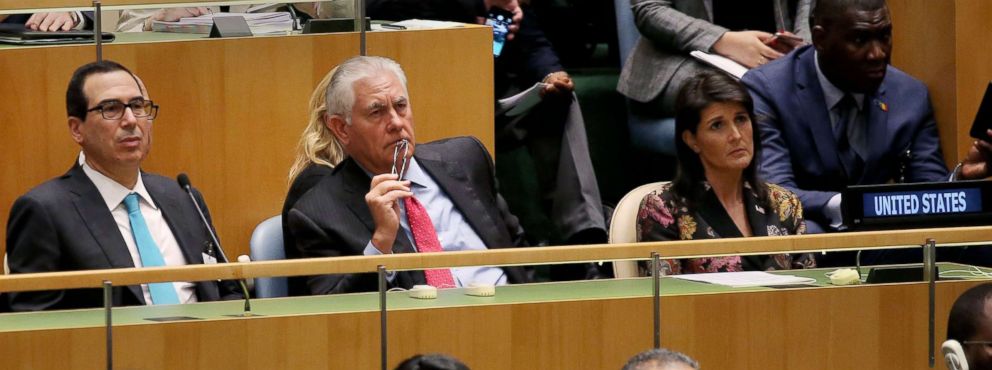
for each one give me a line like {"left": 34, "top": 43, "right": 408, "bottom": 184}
{"left": 741, "top": 46, "right": 948, "bottom": 221}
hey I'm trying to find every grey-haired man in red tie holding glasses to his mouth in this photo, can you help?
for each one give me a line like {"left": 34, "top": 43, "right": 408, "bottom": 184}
{"left": 289, "top": 57, "right": 529, "bottom": 294}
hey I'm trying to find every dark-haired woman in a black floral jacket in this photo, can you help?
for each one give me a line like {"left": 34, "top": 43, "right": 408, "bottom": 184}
{"left": 637, "top": 72, "right": 815, "bottom": 274}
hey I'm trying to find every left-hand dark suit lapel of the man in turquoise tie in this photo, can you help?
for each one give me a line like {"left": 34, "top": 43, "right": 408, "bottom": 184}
{"left": 67, "top": 164, "right": 145, "bottom": 304}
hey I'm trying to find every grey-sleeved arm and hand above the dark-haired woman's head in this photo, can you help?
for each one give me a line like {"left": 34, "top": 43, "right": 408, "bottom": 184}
{"left": 630, "top": 0, "right": 782, "bottom": 68}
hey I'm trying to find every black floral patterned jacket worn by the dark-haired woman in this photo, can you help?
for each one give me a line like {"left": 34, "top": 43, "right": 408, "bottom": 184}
{"left": 637, "top": 182, "right": 816, "bottom": 274}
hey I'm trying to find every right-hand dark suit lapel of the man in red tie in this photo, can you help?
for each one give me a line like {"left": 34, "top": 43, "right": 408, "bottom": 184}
{"left": 417, "top": 153, "right": 503, "bottom": 248}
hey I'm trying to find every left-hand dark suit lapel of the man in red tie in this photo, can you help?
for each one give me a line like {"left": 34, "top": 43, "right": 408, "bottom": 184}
{"left": 334, "top": 157, "right": 416, "bottom": 253}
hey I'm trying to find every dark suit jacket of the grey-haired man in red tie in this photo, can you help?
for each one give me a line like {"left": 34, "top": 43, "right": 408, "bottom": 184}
{"left": 289, "top": 137, "right": 529, "bottom": 294}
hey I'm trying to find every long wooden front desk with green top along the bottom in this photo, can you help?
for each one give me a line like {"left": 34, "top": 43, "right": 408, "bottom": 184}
{"left": 0, "top": 268, "right": 978, "bottom": 370}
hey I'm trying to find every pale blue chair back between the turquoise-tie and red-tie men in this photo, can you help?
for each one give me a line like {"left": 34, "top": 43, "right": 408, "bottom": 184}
{"left": 249, "top": 216, "right": 289, "bottom": 298}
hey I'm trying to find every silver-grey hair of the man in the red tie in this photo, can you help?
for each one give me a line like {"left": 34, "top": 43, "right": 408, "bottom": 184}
{"left": 325, "top": 56, "right": 409, "bottom": 123}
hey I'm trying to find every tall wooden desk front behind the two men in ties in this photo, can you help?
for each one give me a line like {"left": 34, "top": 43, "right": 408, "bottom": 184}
{"left": 0, "top": 26, "right": 494, "bottom": 256}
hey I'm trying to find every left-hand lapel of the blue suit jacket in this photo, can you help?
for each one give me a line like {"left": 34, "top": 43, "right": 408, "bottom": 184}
{"left": 795, "top": 47, "right": 847, "bottom": 181}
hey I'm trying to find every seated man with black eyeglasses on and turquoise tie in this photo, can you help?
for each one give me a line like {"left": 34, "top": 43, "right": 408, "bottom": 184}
{"left": 7, "top": 61, "right": 238, "bottom": 311}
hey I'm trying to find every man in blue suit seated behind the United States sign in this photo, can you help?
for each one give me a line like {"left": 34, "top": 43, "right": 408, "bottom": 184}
{"left": 742, "top": 0, "right": 990, "bottom": 264}
